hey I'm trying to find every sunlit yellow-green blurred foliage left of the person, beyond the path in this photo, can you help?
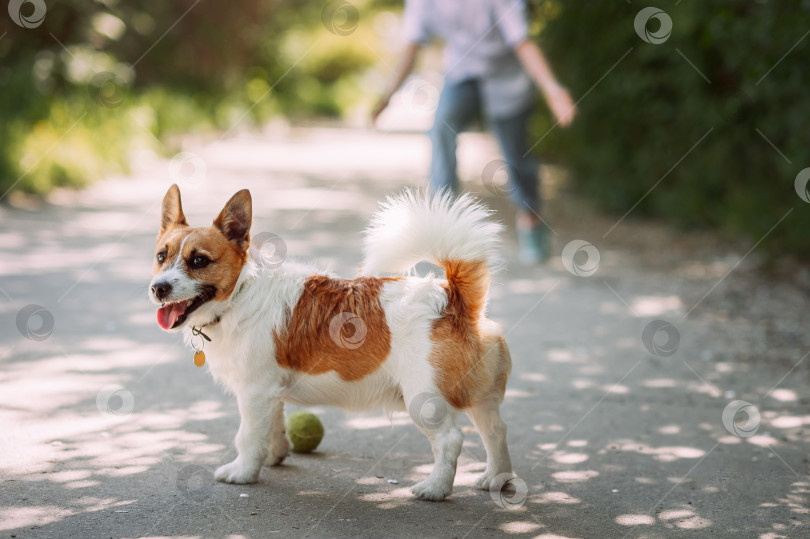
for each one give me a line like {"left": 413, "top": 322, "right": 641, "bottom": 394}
{"left": 0, "top": 0, "right": 377, "bottom": 197}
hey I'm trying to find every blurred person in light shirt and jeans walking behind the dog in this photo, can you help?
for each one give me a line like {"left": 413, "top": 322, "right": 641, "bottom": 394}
{"left": 371, "top": 0, "right": 576, "bottom": 264}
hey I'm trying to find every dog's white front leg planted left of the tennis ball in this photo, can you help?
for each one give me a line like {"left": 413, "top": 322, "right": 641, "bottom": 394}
{"left": 214, "top": 391, "right": 284, "bottom": 483}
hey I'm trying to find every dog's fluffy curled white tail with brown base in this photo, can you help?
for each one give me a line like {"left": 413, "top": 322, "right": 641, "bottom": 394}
{"left": 363, "top": 191, "right": 503, "bottom": 318}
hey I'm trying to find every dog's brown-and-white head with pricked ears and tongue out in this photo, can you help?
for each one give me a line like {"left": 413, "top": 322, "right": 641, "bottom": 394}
{"left": 149, "top": 185, "right": 252, "bottom": 331}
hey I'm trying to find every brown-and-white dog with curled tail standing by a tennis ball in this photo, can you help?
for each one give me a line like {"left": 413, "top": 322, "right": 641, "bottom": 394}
{"left": 149, "top": 185, "right": 512, "bottom": 500}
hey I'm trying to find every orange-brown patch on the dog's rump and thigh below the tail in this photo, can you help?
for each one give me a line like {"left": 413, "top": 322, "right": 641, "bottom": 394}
{"left": 429, "top": 261, "right": 511, "bottom": 409}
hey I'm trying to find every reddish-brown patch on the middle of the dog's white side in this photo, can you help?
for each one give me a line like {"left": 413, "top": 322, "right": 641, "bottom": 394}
{"left": 273, "top": 275, "right": 396, "bottom": 381}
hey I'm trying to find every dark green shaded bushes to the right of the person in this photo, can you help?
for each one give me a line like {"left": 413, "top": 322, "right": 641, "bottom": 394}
{"left": 535, "top": 0, "right": 810, "bottom": 256}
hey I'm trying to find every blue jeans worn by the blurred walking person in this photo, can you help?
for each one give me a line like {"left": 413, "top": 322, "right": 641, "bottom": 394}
{"left": 430, "top": 80, "right": 540, "bottom": 212}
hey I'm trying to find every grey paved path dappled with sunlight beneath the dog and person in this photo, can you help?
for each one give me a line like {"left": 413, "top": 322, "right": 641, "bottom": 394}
{"left": 0, "top": 129, "right": 810, "bottom": 537}
